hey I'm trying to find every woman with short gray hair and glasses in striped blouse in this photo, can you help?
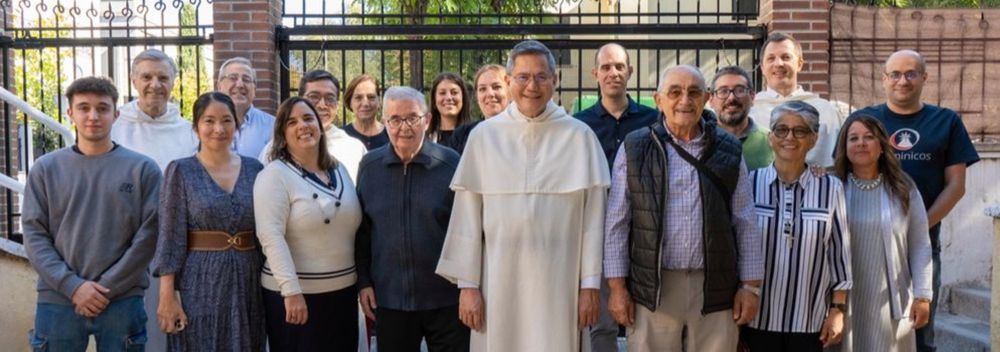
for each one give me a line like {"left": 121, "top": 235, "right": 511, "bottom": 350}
{"left": 743, "top": 101, "right": 851, "bottom": 352}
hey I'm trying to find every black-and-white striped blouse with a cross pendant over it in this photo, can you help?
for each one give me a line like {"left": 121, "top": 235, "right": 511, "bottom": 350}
{"left": 750, "top": 164, "right": 851, "bottom": 333}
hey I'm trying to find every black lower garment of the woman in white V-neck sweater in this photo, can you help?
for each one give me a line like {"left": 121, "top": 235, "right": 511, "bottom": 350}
{"left": 264, "top": 286, "right": 358, "bottom": 352}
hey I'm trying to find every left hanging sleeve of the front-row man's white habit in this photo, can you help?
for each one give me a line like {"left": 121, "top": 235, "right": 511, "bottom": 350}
{"left": 435, "top": 190, "right": 484, "bottom": 286}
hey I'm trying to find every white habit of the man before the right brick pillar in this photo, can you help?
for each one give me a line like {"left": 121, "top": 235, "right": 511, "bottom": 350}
{"left": 750, "top": 86, "right": 847, "bottom": 167}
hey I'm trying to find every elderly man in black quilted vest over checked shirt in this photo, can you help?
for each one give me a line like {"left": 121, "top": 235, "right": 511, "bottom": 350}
{"left": 604, "top": 65, "right": 764, "bottom": 352}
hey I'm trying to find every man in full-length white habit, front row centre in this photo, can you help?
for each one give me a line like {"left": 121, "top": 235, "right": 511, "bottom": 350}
{"left": 437, "top": 40, "right": 610, "bottom": 352}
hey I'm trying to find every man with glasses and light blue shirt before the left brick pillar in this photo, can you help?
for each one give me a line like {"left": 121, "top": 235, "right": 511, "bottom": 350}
{"left": 215, "top": 56, "right": 274, "bottom": 158}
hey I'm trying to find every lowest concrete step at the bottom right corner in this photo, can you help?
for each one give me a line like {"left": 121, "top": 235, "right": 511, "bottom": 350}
{"left": 934, "top": 312, "right": 990, "bottom": 352}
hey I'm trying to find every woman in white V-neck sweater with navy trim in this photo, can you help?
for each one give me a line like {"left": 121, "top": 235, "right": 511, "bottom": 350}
{"left": 254, "top": 97, "right": 361, "bottom": 351}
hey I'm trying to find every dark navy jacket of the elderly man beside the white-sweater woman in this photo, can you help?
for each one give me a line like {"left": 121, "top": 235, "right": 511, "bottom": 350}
{"left": 355, "top": 140, "right": 459, "bottom": 311}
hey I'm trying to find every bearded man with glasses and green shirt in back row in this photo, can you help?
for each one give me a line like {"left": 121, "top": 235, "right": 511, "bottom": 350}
{"left": 708, "top": 66, "right": 774, "bottom": 170}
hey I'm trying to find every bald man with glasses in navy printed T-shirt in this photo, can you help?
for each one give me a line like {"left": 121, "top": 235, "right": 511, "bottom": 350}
{"left": 854, "top": 50, "right": 979, "bottom": 351}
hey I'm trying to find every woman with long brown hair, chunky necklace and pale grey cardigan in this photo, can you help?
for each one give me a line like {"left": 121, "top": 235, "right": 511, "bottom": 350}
{"left": 834, "top": 114, "right": 934, "bottom": 351}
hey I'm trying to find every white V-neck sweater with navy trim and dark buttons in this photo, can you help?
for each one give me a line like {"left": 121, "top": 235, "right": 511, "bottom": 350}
{"left": 253, "top": 160, "right": 361, "bottom": 297}
